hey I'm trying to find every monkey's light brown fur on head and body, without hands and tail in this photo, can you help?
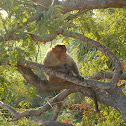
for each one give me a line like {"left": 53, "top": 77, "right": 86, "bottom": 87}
{"left": 43, "top": 44, "right": 79, "bottom": 84}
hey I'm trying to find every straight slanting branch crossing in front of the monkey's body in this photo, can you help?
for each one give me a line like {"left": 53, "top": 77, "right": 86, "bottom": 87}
{"left": 18, "top": 60, "right": 110, "bottom": 89}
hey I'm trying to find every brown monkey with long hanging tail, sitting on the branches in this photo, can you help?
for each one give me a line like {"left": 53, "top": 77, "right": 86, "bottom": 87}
{"left": 43, "top": 43, "right": 99, "bottom": 112}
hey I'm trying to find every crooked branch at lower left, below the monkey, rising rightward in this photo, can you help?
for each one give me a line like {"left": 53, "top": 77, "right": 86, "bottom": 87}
{"left": 0, "top": 90, "right": 72, "bottom": 121}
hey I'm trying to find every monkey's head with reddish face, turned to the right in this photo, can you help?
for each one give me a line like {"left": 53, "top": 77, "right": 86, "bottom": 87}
{"left": 52, "top": 44, "right": 67, "bottom": 61}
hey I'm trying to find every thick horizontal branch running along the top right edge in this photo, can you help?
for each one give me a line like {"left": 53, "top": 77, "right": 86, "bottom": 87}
{"left": 59, "top": 0, "right": 126, "bottom": 13}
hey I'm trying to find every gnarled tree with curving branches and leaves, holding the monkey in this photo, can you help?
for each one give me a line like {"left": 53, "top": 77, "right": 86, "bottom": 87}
{"left": 0, "top": 0, "right": 126, "bottom": 125}
